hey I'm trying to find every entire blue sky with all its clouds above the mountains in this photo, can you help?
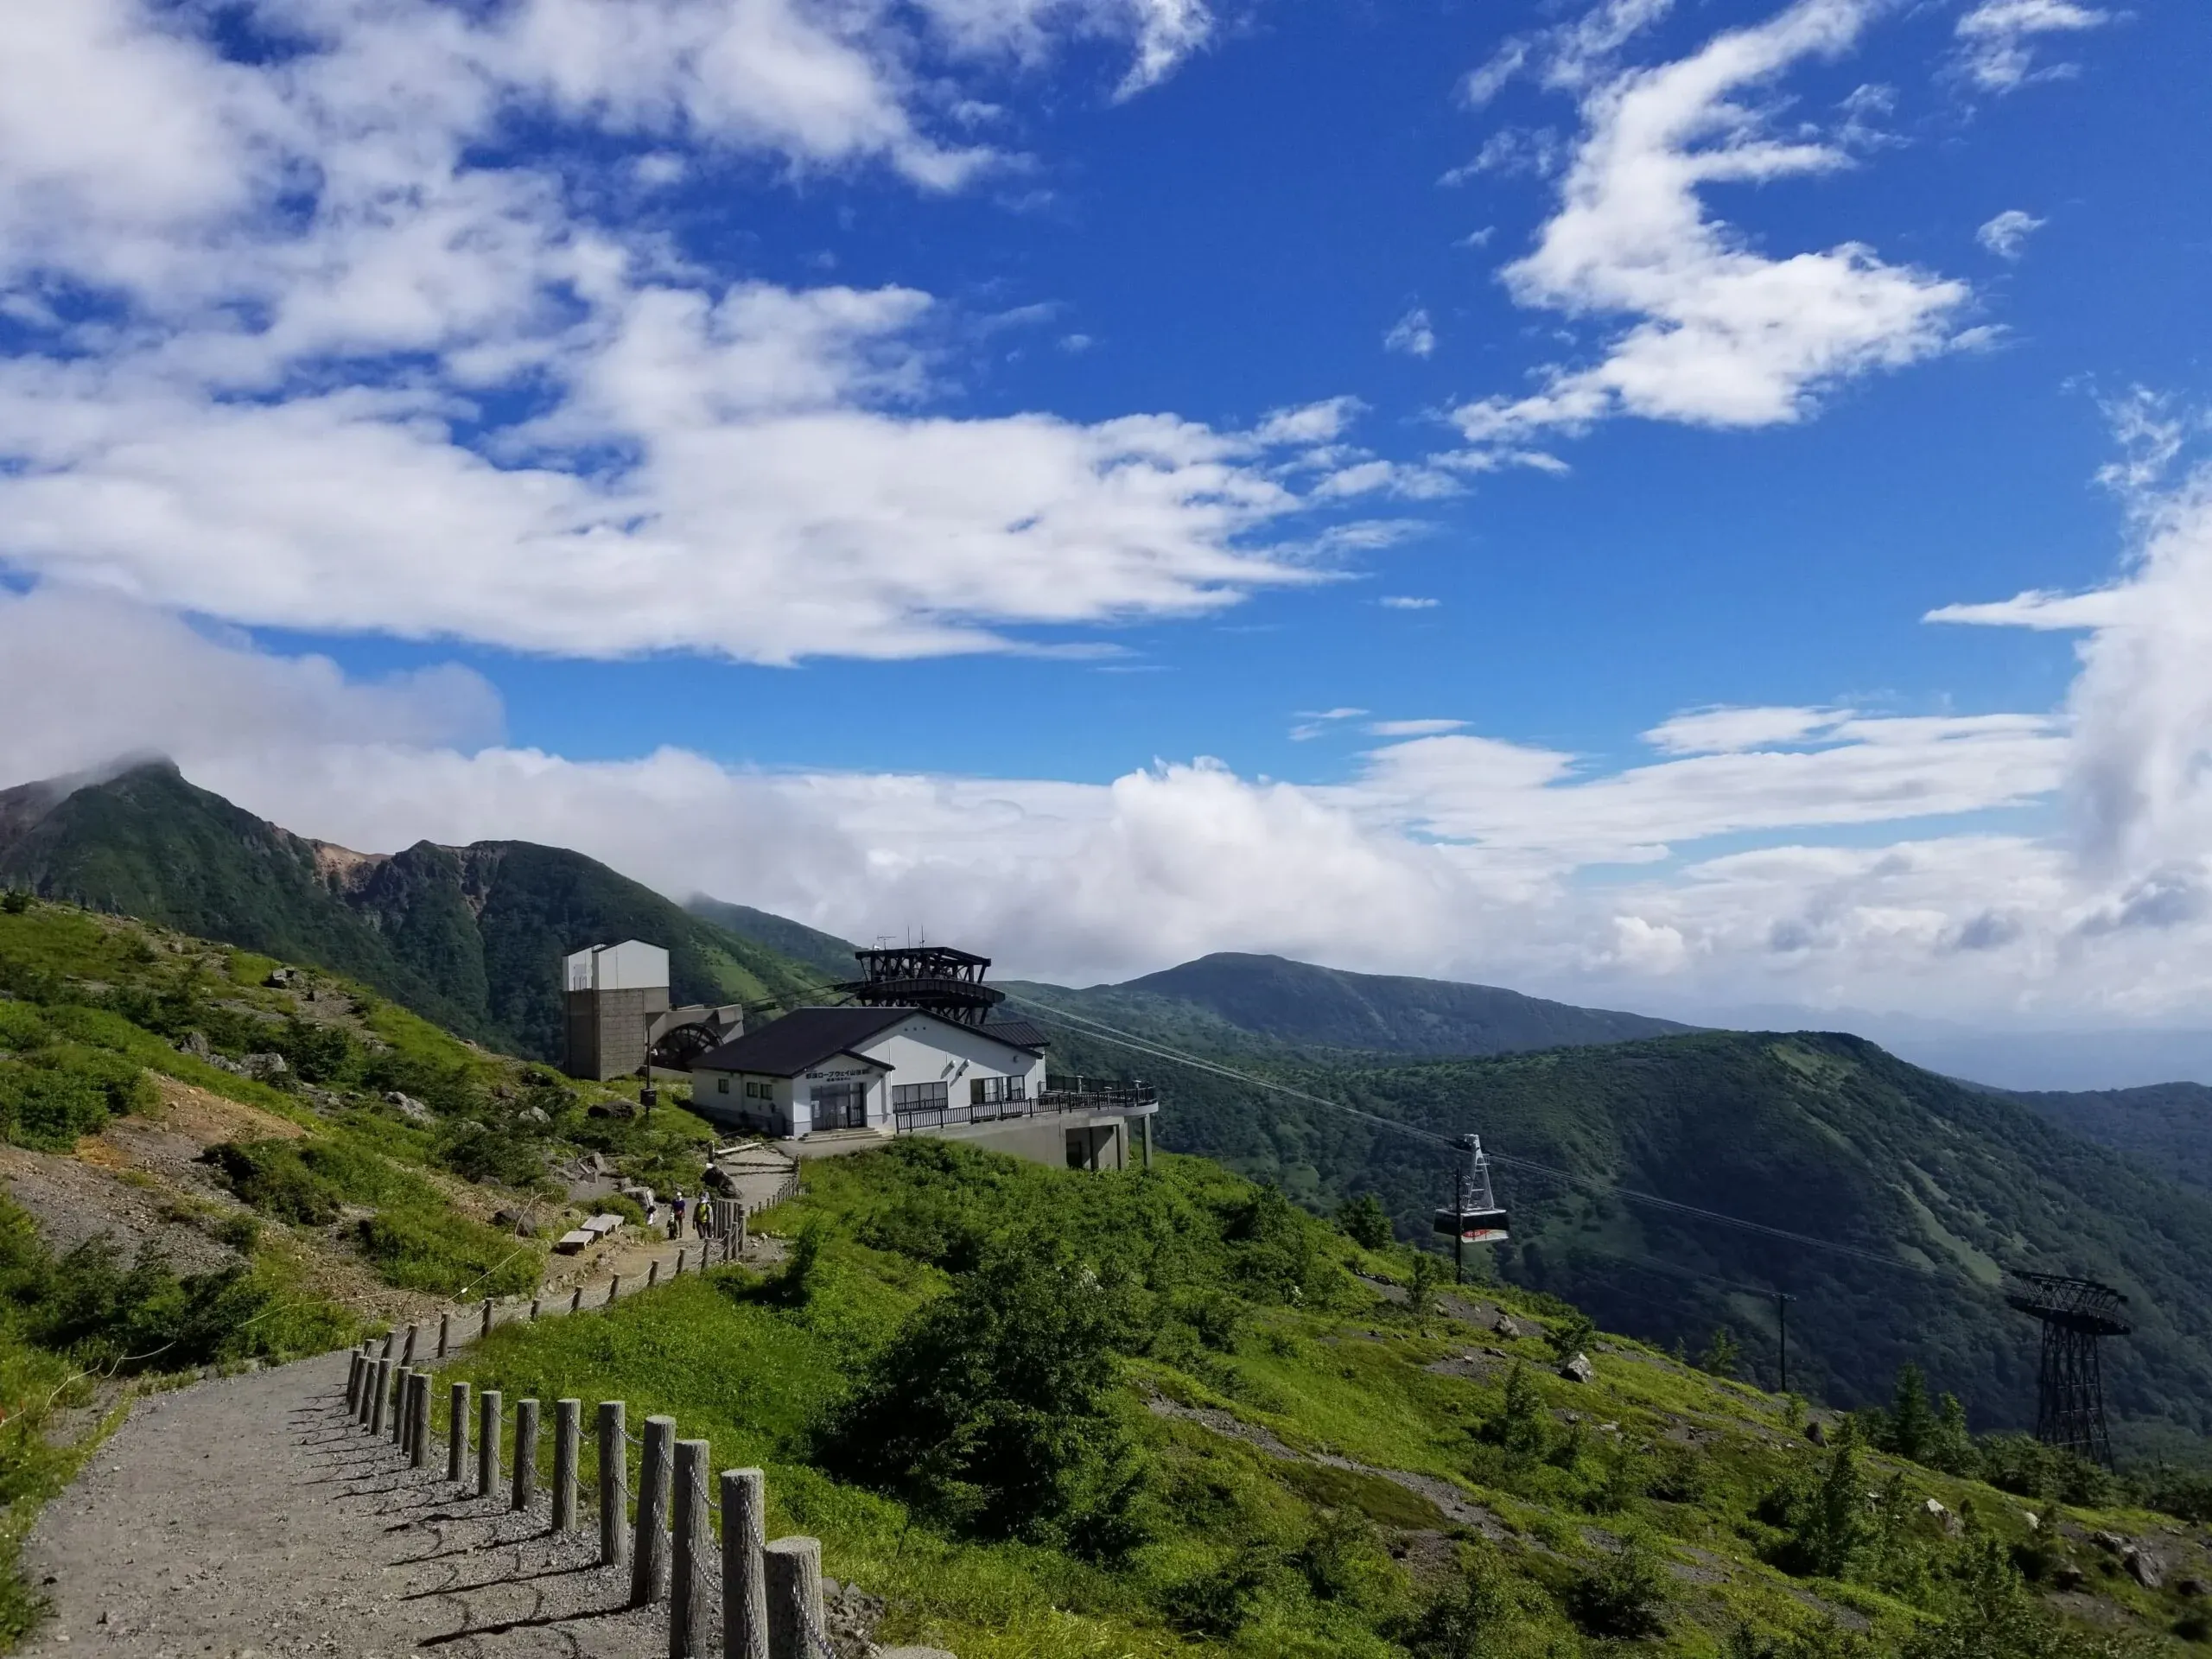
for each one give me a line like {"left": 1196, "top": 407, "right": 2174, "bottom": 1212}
{"left": 0, "top": 0, "right": 2212, "bottom": 1024}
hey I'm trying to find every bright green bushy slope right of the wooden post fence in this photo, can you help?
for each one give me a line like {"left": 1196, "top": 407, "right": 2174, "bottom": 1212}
{"left": 455, "top": 1141, "right": 2208, "bottom": 1659}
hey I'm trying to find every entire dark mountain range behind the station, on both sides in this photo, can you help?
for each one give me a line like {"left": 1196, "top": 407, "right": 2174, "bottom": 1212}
{"left": 21, "top": 766, "right": 2212, "bottom": 1445}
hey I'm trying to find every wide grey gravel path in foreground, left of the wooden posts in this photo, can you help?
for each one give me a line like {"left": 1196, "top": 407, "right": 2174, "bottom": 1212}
{"left": 24, "top": 1354, "right": 721, "bottom": 1659}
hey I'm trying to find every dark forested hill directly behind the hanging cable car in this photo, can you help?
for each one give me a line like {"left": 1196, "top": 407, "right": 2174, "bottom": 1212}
{"left": 1021, "top": 1028, "right": 2212, "bottom": 1442}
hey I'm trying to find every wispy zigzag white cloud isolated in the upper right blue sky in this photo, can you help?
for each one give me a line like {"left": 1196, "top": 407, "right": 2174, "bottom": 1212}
{"left": 1453, "top": 0, "right": 1968, "bottom": 465}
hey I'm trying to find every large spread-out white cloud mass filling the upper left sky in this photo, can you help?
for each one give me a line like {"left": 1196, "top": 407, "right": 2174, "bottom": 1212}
{"left": 0, "top": 0, "right": 1318, "bottom": 661}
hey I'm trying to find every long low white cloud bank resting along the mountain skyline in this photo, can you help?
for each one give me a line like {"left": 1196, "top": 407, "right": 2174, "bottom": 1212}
{"left": 13, "top": 566, "right": 2212, "bottom": 1024}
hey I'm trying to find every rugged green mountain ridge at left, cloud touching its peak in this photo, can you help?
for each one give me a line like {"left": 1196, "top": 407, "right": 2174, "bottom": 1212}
{"left": 0, "top": 763, "right": 825, "bottom": 1058}
